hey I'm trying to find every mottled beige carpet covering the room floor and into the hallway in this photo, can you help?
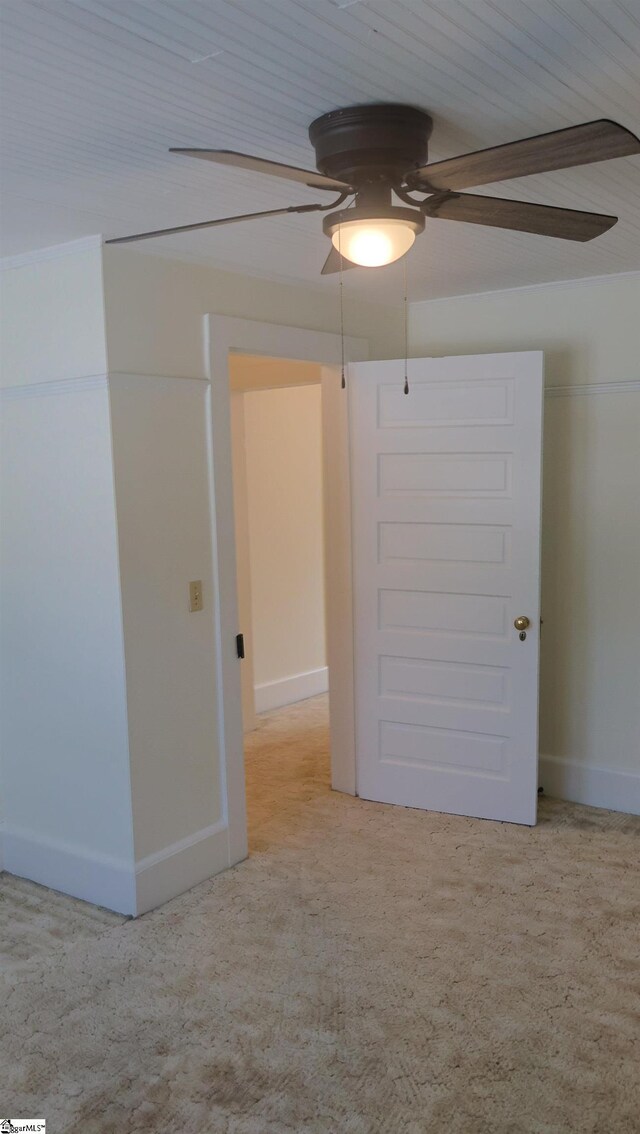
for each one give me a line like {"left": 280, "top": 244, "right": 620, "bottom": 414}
{"left": 0, "top": 699, "right": 640, "bottom": 1134}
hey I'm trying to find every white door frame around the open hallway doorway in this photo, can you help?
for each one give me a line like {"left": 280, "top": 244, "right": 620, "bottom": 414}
{"left": 203, "top": 314, "right": 369, "bottom": 865}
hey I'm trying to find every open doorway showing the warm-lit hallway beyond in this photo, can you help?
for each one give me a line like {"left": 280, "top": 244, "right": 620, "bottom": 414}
{"left": 229, "top": 353, "right": 330, "bottom": 851}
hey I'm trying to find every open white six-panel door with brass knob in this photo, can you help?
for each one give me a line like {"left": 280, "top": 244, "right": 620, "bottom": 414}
{"left": 348, "top": 352, "right": 542, "bottom": 823}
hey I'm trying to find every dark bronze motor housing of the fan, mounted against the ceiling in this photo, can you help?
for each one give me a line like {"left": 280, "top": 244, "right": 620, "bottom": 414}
{"left": 309, "top": 103, "right": 433, "bottom": 187}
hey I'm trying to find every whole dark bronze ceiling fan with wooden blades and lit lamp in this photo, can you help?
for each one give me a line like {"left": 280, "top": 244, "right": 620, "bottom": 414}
{"left": 107, "top": 103, "right": 640, "bottom": 274}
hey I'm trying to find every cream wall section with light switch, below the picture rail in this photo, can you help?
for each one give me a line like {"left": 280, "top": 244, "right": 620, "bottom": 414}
{"left": 110, "top": 374, "right": 222, "bottom": 861}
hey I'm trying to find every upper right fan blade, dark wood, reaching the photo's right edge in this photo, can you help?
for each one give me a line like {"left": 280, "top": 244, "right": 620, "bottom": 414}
{"left": 406, "top": 118, "right": 640, "bottom": 189}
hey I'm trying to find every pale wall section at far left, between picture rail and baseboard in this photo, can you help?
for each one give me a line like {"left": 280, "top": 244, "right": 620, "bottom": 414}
{"left": 0, "top": 378, "right": 134, "bottom": 913}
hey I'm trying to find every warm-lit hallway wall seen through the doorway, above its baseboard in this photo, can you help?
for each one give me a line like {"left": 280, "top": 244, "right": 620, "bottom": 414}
{"left": 244, "top": 384, "right": 327, "bottom": 711}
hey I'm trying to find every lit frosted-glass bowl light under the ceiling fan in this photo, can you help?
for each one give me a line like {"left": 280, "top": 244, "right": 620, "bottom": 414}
{"left": 323, "top": 205, "right": 424, "bottom": 268}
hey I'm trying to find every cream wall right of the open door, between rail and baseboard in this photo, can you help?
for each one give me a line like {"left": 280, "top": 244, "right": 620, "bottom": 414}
{"left": 540, "top": 392, "right": 640, "bottom": 780}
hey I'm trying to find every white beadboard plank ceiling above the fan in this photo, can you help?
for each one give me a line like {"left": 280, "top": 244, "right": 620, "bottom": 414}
{"left": 0, "top": 0, "right": 640, "bottom": 302}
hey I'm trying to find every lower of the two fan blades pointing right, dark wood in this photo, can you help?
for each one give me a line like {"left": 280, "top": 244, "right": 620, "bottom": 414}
{"left": 421, "top": 193, "right": 617, "bottom": 240}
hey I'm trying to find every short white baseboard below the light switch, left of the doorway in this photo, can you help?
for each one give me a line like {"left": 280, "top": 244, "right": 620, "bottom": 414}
{"left": 135, "top": 820, "right": 229, "bottom": 914}
